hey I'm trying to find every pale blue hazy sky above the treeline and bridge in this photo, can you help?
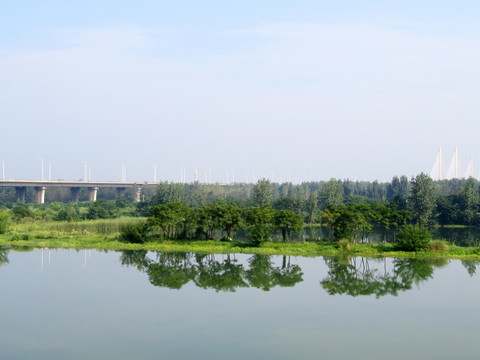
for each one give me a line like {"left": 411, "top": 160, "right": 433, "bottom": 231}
{"left": 0, "top": 0, "right": 480, "bottom": 183}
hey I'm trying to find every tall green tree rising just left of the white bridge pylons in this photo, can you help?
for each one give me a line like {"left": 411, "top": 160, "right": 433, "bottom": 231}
{"left": 408, "top": 172, "right": 436, "bottom": 226}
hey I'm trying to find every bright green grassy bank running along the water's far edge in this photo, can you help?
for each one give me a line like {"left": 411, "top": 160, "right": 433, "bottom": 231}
{"left": 0, "top": 218, "right": 480, "bottom": 260}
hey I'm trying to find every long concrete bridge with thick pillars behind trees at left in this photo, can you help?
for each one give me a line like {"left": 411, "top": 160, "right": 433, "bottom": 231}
{"left": 0, "top": 180, "right": 157, "bottom": 204}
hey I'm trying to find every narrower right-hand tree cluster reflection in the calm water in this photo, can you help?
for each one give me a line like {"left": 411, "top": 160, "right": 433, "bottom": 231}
{"left": 320, "top": 257, "right": 449, "bottom": 298}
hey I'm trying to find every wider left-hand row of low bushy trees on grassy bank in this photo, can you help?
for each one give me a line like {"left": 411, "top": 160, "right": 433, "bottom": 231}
{"left": 121, "top": 199, "right": 304, "bottom": 245}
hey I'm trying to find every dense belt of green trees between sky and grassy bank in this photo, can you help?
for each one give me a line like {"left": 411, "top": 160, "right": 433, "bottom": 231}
{"left": 0, "top": 173, "right": 480, "bottom": 250}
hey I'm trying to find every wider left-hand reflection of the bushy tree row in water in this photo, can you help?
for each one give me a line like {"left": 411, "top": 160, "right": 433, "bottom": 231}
{"left": 120, "top": 250, "right": 303, "bottom": 292}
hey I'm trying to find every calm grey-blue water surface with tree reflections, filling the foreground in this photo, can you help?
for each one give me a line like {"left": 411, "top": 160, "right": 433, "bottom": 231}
{"left": 0, "top": 249, "right": 480, "bottom": 359}
